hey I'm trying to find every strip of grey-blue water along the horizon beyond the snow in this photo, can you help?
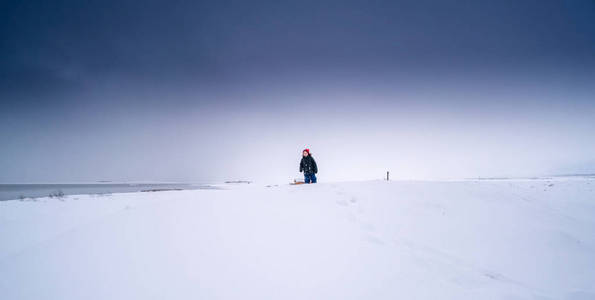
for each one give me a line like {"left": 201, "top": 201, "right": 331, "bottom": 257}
{"left": 0, "top": 183, "right": 217, "bottom": 201}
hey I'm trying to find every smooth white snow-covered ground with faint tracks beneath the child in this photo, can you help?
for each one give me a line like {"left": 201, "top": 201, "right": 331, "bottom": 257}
{"left": 0, "top": 178, "right": 595, "bottom": 300}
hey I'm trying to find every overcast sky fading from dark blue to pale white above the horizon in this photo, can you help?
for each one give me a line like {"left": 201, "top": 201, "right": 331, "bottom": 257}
{"left": 0, "top": 0, "right": 595, "bottom": 182}
